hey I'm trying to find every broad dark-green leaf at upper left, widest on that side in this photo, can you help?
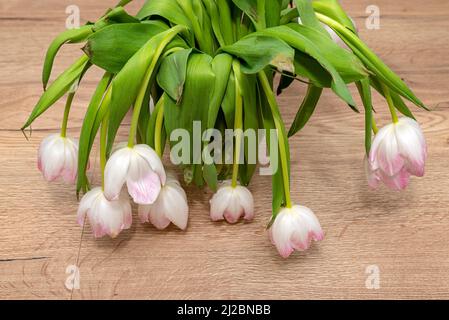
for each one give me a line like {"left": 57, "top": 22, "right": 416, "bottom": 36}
{"left": 83, "top": 22, "right": 175, "bottom": 73}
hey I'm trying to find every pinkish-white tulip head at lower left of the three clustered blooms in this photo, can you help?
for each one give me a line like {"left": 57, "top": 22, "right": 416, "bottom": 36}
{"left": 78, "top": 187, "right": 132, "bottom": 238}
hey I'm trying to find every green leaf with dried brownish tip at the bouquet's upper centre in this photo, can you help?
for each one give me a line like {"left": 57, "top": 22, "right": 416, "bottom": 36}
{"left": 221, "top": 35, "right": 295, "bottom": 74}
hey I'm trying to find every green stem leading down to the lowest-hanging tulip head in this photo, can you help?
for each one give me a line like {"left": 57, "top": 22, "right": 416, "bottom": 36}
{"left": 258, "top": 71, "right": 292, "bottom": 208}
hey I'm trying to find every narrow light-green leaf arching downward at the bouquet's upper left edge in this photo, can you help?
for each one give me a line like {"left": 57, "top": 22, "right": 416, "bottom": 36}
{"left": 42, "top": 25, "right": 93, "bottom": 90}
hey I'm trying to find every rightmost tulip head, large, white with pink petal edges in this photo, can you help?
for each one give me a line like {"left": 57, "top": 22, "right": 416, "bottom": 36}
{"left": 366, "top": 118, "right": 427, "bottom": 190}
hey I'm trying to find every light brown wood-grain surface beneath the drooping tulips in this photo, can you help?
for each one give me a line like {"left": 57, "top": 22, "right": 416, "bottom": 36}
{"left": 0, "top": 0, "right": 449, "bottom": 299}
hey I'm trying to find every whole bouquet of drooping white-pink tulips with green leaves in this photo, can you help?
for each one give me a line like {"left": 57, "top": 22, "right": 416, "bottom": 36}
{"left": 22, "top": 0, "right": 427, "bottom": 257}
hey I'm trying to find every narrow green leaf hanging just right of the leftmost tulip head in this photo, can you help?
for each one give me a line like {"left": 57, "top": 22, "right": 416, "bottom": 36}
{"left": 76, "top": 73, "right": 112, "bottom": 193}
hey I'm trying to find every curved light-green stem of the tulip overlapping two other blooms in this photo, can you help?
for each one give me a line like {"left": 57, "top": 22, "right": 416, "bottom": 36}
{"left": 128, "top": 26, "right": 185, "bottom": 148}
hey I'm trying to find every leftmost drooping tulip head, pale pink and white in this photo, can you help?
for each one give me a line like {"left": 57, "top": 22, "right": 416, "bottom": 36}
{"left": 37, "top": 134, "right": 78, "bottom": 183}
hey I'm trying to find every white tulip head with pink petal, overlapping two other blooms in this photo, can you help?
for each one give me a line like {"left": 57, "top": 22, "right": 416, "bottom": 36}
{"left": 104, "top": 145, "right": 166, "bottom": 205}
